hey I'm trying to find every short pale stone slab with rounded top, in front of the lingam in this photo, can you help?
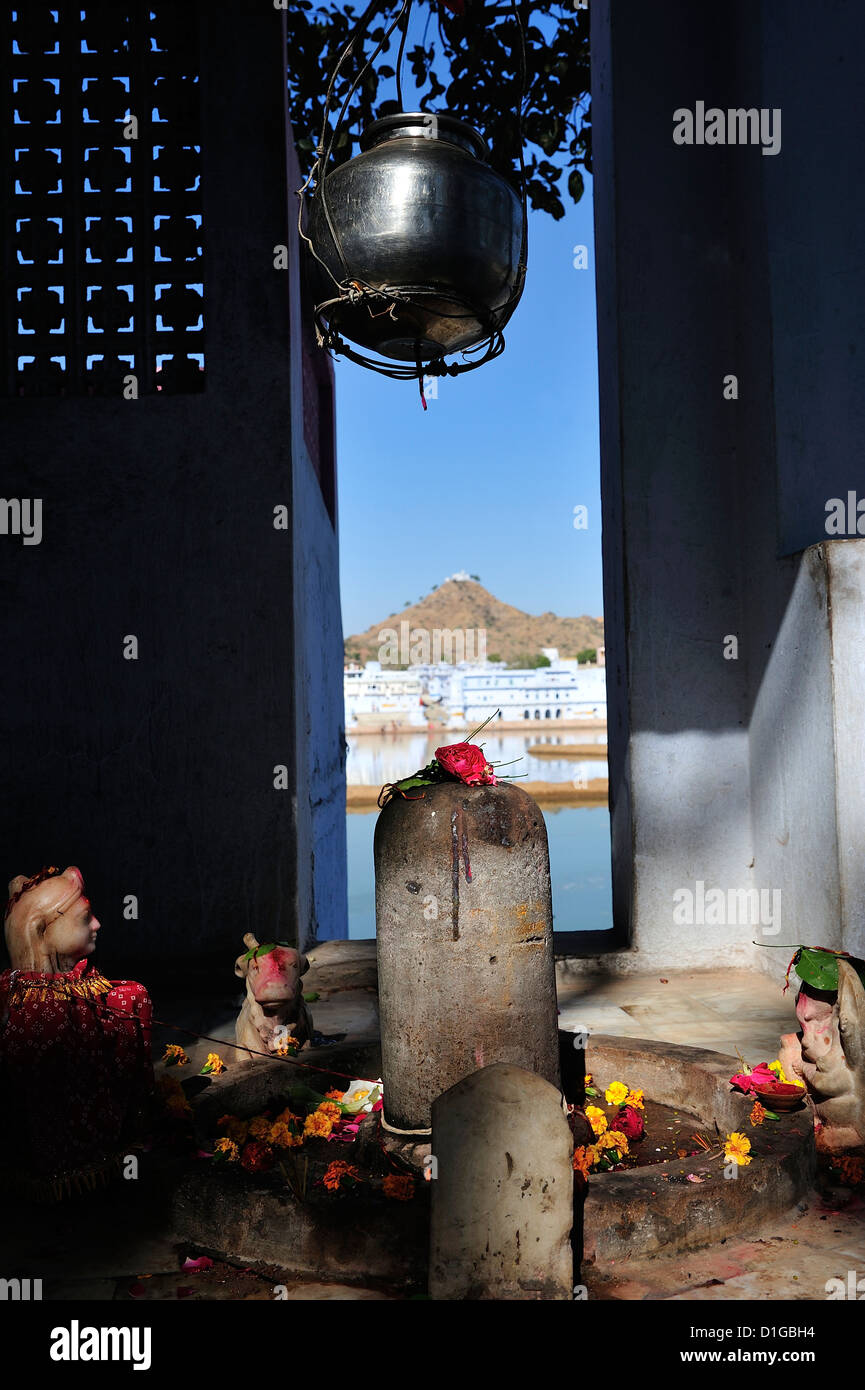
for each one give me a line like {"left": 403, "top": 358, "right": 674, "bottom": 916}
{"left": 430, "top": 1062, "right": 573, "bottom": 1300}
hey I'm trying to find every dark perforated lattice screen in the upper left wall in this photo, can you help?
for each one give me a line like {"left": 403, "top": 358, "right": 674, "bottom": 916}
{"left": 0, "top": 0, "right": 206, "bottom": 396}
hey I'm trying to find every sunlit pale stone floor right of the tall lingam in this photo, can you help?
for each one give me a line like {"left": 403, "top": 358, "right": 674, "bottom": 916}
{"left": 558, "top": 970, "right": 798, "bottom": 1066}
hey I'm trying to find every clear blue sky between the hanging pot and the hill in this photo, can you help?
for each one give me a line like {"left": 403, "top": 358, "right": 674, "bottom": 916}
{"left": 335, "top": 186, "right": 602, "bottom": 635}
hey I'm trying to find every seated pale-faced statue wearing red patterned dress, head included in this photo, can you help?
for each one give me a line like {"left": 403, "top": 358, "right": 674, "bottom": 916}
{"left": 0, "top": 866, "right": 153, "bottom": 1200}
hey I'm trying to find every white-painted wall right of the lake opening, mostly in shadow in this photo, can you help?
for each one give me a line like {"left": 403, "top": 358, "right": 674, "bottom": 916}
{"left": 591, "top": 0, "right": 865, "bottom": 974}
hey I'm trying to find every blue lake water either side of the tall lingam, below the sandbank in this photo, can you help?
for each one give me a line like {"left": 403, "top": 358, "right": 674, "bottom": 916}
{"left": 346, "top": 806, "right": 613, "bottom": 938}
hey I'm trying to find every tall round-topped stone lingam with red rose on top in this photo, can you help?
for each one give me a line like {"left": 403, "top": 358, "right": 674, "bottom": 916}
{"left": 375, "top": 783, "right": 559, "bottom": 1133}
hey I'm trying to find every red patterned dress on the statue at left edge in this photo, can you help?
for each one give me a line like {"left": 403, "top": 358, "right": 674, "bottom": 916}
{"left": 0, "top": 960, "right": 153, "bottom": 1200}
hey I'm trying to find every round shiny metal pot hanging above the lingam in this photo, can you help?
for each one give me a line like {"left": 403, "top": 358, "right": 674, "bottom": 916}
{"left": 309, "top": 113, "right": 526, "bottom": 363}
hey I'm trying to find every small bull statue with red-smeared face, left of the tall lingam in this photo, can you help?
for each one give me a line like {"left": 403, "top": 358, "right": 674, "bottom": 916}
{"left": 234, "top": 931, "right": 313, "bottom": 1061}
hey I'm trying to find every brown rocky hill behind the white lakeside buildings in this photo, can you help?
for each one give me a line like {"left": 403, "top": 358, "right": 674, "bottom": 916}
{"left": 345, "top": 578, "right": 604, "bottom": 666}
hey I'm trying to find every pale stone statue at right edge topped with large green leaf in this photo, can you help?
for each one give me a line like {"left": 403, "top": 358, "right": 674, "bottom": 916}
{"left": 779, "top": 947, "right": 865, "bottom": 1154}
